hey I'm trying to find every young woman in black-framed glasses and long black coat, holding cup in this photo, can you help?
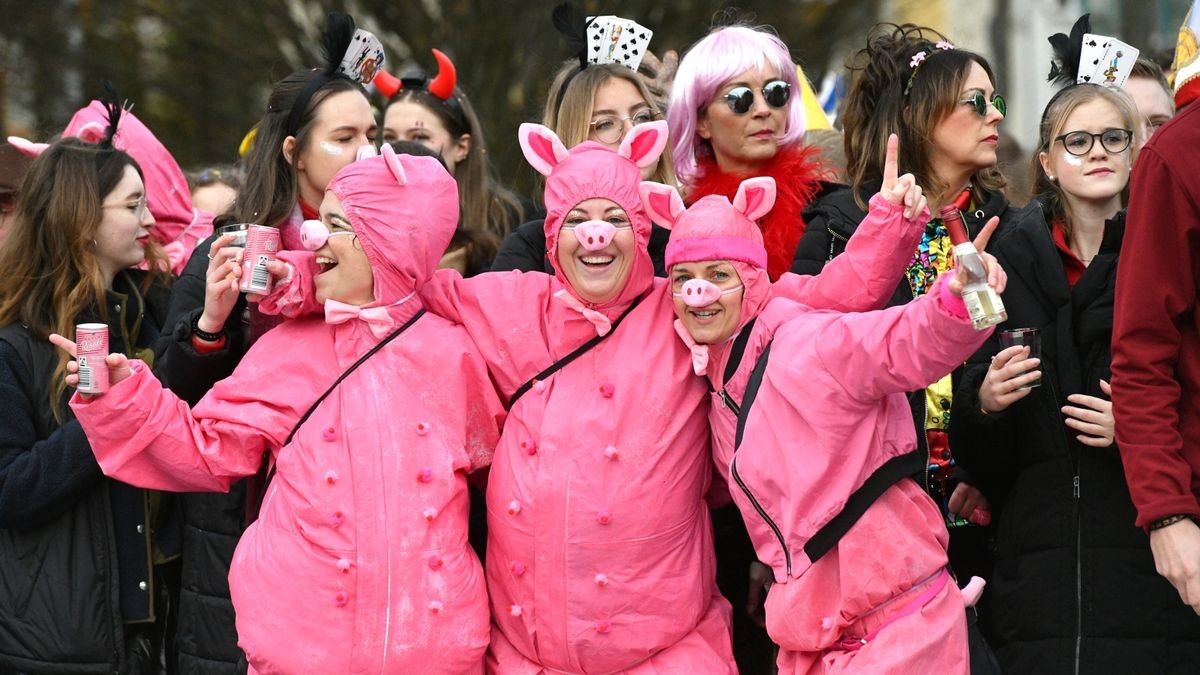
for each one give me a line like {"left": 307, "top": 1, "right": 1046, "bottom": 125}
{"left": 950, "top": 70, "right": 1200, "bottom": 674}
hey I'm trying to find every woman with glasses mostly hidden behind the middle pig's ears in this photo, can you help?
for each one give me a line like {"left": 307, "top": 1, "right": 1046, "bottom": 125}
{"left": 492, "top": 59, "right": 676, "bottom": 276}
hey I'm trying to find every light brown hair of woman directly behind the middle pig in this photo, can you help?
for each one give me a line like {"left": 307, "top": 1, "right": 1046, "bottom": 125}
{"left": 541, "top": 59, "right": 678, "bottom": 185}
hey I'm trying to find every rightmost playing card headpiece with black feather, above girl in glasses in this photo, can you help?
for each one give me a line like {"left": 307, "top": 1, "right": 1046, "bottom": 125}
{"left": 1046, "top": 14, "right": 1139, "bottom": 89}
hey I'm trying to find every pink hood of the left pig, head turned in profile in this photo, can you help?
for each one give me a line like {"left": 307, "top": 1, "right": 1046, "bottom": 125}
{"left": 326, "top": 144, "right": 458, "bottom": 306}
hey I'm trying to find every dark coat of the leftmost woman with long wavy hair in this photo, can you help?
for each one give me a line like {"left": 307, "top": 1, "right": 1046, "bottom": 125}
{"left": 0, "top": 273, "right": 180, "bottom": 673}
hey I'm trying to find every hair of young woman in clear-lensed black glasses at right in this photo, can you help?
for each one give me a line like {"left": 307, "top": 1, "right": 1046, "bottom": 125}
{"left": 1031, "top": 84, "right": 1138, "bottom": 238}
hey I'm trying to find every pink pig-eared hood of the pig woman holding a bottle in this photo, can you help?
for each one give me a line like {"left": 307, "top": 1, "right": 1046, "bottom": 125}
{"left": 640, "top": 177, "right": 775, "bottom": 375}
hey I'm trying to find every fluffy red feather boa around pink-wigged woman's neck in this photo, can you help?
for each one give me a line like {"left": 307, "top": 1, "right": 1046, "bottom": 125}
{"left": 688, "top": 145, "right": 826, "bottom": 280}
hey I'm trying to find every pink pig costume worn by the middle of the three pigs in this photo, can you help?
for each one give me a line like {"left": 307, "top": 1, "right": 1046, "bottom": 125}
{"left": 398, "top": 123, "right": 920, "bottom": 675}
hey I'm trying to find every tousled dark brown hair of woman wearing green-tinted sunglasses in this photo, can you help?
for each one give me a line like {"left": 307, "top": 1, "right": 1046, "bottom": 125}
{"left": 841, "top": 24, "right": 1004, "bottom": 209}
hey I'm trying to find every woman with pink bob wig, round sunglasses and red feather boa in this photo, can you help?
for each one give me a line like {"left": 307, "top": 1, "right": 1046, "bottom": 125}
{"left": 667, "top": 25, "right": 822, "bottom": 279}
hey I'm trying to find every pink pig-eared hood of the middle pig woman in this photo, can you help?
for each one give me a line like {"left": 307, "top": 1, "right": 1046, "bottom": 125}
{"left": 517, "top": 120, "right": 667, "bottom": 305}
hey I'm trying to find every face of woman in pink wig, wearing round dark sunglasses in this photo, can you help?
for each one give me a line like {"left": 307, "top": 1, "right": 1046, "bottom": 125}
{"left": 696, "top": 65, "right": 797, "bottom": 174}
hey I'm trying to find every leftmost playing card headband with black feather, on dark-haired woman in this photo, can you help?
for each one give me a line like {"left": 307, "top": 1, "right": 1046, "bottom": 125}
{"left": 287, "top": 12, "right": 384, "bottom": 136}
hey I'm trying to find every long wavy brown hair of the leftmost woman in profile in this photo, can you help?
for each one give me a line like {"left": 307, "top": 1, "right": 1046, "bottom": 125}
{"left": 0, "top": 138, "right": 166, "bottom": 420}
